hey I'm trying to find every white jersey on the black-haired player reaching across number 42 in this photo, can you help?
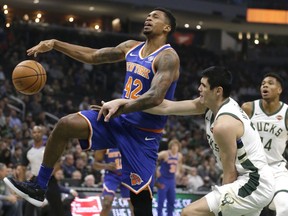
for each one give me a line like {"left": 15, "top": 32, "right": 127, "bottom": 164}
{"left": 205, "top": 98, "right": 267, "bottom": 176}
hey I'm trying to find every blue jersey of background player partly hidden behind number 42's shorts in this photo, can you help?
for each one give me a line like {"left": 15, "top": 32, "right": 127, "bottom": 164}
{"left": 104, "top": 148, "right": 122, "bottom": 175}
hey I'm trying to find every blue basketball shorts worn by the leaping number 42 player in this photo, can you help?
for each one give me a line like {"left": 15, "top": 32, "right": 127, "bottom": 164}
{"left": 78, "top": 110, "right": 162, "bottom": 196}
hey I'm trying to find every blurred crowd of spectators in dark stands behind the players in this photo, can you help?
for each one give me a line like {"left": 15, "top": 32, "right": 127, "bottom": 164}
{"left": 0, "top": 20, "right": 288, "bottom": 201}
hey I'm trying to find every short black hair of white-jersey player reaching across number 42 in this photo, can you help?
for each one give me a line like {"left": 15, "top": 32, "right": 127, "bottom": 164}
{"left": 202, "top": 66, "right": 232, "bottom": 98}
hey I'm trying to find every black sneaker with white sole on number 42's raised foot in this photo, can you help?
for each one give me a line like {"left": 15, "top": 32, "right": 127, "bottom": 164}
{"left": 3, "top": 177, "right": 47, "bottom": 207}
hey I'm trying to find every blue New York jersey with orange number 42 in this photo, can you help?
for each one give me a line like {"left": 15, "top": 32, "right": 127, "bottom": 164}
{"left": 122, "top": 42, "right": 176, "bottom": 130}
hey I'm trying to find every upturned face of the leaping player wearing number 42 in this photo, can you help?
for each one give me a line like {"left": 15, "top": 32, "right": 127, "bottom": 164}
{"left": 143, "top": 10, "right": 169, "bottom": 36}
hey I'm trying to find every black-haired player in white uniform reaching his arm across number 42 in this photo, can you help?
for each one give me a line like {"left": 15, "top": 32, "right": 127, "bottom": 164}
{"left": 102, "top": 67, "right": 274, "bottom": 216}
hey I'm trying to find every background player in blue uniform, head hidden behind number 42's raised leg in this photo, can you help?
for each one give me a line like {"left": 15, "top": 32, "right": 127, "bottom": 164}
{"left": 93, "top": 148, "right": 133, "bottom": 216}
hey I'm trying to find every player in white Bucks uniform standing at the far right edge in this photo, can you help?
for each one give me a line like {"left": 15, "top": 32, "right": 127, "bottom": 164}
{"left": 242, "top": 73, "right": 288, "bottom": 216}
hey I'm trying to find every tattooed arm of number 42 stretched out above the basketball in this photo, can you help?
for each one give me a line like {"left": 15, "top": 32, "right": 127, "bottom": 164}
{"left": 27, "top": 39, "right": 139, "bottom": 64}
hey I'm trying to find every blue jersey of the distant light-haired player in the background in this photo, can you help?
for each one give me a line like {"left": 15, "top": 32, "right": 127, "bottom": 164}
{"left": 160, "top": 151, "right": 178, "bottom": 179}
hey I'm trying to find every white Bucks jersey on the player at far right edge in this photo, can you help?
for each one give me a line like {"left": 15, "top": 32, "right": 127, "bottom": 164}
{"left": 251, "top": 100, "right": 288, "bottom": 165}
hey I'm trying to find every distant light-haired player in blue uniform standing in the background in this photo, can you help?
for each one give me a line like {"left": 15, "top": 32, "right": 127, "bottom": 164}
{"left": 156, "top": 139, "right": 182, "bottom": 216}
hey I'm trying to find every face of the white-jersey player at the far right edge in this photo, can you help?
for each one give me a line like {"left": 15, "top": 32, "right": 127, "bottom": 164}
{"left": 260, "top": 76, "right": 282, "bottom": 99}
